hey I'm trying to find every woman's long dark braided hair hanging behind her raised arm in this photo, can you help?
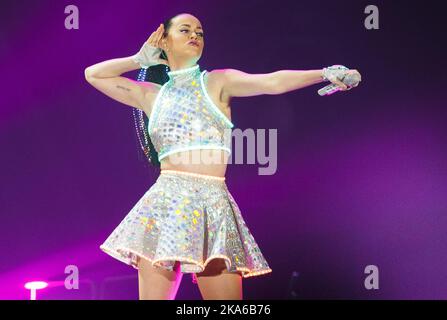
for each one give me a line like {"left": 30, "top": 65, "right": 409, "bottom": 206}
{"left": 132, "top": 15, "right": 177, "bottom": 167}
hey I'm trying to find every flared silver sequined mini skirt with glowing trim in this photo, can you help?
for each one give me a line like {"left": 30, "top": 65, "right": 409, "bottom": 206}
{"left": 100, "top": 170, "right": 272, "bottom": 283}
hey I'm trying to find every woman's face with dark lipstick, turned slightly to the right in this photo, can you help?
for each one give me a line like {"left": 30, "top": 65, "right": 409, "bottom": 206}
{"left": 166, "top": 14, "right": 204, "bottom": 60}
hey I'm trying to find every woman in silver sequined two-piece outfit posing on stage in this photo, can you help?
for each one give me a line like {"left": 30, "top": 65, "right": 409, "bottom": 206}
{"left": 85, "top": 13, "right": 360, "bottom": 300}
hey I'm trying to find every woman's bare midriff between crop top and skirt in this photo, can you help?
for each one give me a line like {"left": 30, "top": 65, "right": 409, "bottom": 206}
{"left": 160, "top": 149, "right": 230, "bottom": 177}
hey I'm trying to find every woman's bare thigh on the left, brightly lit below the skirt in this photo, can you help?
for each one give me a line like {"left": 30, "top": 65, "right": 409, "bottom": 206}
{"left": 138, "top": 259, "right": 183, "bottom": 300}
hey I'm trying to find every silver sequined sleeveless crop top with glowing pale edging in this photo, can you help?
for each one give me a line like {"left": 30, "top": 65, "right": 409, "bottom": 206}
{"left": 148, "top": 64, "right": 234, "bottom": 160}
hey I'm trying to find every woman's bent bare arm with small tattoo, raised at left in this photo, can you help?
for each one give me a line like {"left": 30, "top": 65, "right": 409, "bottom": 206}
{"left": 84, "top": 57, "right": 156, "bottom": 112}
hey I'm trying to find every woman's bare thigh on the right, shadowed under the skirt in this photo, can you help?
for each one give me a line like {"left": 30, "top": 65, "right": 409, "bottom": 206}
{"left": 196, "top": 258, "right": 242, "bottom": 300}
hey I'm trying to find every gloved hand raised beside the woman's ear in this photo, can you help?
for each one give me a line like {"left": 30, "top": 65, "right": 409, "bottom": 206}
{"left": 133, "top": 24, "right": 169, "bottom": 68}
